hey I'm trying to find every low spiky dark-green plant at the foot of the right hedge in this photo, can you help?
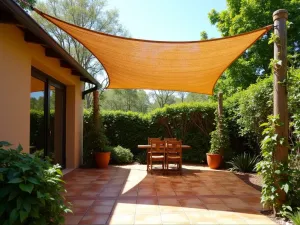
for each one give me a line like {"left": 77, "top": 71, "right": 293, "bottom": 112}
{"left": 227, "top": 152, "right": 260, "bottom": 173}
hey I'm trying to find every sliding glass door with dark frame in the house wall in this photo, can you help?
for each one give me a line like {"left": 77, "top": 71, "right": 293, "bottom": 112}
{"left": 30, "top": 68, "right": 66, "bottom": 168}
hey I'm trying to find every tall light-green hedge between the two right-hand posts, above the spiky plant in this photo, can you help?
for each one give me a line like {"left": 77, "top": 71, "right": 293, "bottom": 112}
{"left": 224, "top": 77, "right": 273, "bottom": 154}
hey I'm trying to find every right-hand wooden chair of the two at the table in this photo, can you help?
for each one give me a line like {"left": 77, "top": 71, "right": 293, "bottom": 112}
{"left": 166, "top": 141, "right": 182, "bottom": 175}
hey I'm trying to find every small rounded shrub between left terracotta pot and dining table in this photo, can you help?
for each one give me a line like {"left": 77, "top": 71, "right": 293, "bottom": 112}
{"left": 109, "top": 146, "right": 133, "bottom": 164}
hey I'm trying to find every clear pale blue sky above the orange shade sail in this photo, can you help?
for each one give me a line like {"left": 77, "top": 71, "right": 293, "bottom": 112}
{"left": 108, "top": 0, "right": 226, "bottom": 41}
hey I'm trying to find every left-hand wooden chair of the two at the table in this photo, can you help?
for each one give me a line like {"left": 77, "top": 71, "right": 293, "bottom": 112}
{"left": 149, "top": 140, "right": 166, "bottom": 174}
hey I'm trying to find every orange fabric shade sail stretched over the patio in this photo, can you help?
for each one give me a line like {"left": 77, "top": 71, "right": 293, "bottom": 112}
{"left": 36, "top": 10, "right": 272, "bottom": 94}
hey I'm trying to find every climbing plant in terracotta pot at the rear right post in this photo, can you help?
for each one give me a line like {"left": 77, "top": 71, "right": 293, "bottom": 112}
{"left": 206, "top": 113, "right": 229, "bottom": 169}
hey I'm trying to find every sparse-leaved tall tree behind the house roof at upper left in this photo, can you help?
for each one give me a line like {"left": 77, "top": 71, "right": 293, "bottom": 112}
{"left": 32, "top": 0, "right": 128, "bottom": 107}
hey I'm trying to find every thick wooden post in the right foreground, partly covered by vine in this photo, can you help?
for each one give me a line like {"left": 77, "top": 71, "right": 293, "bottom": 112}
{"left": 273, "top": 9, "right": 289, "bottom": 207}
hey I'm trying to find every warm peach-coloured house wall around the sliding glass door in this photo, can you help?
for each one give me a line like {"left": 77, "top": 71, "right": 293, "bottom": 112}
{"left": 0, "top": 24, "right": 83, "bottom": 168}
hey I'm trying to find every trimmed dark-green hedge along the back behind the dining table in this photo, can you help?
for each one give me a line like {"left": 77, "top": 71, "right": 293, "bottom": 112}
{"left": 84, "top": 103, "right": 216, "bottom": 163}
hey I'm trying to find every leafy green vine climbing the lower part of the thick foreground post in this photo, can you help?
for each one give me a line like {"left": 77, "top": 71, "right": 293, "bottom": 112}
{"left": 257, "top": 115, "right": 300, "bottom": 216}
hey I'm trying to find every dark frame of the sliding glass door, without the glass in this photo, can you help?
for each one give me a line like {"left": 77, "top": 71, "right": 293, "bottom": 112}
{"left": 31, "top": 67, "right": 66, "bottom": 168}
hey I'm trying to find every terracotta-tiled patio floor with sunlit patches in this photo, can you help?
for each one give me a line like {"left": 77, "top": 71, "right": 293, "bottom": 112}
{"left": 65, "top": 165, "right": 274, "bottom": 224}
